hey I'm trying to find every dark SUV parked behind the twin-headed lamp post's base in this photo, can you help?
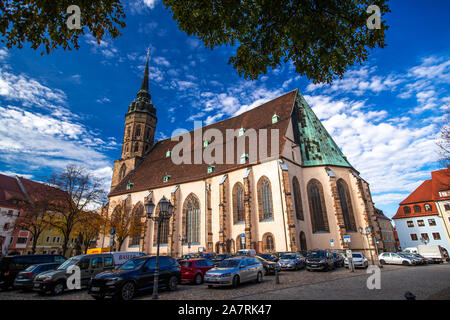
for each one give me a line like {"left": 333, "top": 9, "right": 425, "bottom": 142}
{"left": 88, "top": 256, "right": 181, "bottom": 300}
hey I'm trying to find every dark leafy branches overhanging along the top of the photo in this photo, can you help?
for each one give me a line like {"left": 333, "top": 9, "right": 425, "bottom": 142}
{"left": 0, "top": 0, "right": 390, "bottom": 83}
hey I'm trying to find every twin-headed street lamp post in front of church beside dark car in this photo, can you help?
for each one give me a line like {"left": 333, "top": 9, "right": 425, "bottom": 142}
{"left": 145, "top": 196, "right": 173, "bottom": 299}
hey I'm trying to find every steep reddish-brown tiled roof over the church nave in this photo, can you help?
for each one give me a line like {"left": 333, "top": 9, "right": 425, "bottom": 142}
{"left": 109, "top": 90, "right": 297, "bottom": 196}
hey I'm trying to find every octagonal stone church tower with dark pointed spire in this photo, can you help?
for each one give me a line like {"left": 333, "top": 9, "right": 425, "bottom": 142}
{"left": 111, "top": 53, "right": 157, "bottom": 190}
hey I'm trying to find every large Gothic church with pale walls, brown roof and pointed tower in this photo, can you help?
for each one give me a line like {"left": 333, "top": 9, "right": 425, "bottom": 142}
{"left": 104, "top": 59, "right": 384, "bottom": 258}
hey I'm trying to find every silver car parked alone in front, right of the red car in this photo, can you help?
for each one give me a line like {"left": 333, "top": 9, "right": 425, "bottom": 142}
{"left": 204, "top": 256, "right": 264, "bottom": 288}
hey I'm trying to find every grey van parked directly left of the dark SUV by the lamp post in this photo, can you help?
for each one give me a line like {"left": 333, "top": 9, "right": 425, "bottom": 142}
{"left": 33, "top": 253, "right": 114, "bottom": 295}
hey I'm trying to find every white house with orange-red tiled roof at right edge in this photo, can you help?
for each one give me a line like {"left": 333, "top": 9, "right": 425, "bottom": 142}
{"left": 393, "top": 169, "right": 450, "bottom": 252}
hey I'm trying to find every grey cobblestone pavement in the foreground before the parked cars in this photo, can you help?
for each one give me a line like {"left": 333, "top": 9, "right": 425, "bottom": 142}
{"left": 0, "top": 263, "right": 450, "bottom": 300}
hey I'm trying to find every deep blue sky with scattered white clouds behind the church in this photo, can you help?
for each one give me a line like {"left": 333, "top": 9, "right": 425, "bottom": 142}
{"left": 0, "top": 0, "right": 450, "bottom": 216}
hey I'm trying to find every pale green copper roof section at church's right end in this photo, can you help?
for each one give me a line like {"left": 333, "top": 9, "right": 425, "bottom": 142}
{"left": 292, "top": 92, "right": 352, "bottom": 168}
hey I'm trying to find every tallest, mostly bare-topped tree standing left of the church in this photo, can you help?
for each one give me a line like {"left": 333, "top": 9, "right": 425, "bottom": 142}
{"left": 49, "top": 165, "right": 106, "bottom": 255}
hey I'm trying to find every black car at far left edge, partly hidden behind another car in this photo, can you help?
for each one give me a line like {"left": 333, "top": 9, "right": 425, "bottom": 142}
{"left": 0, "top": 254, "right": 66, "bottom": 290}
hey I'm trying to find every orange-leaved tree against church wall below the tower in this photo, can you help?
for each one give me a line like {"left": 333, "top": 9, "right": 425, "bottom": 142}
{"left": 110, "top": 198, "right": 144, "bottom": 250}
